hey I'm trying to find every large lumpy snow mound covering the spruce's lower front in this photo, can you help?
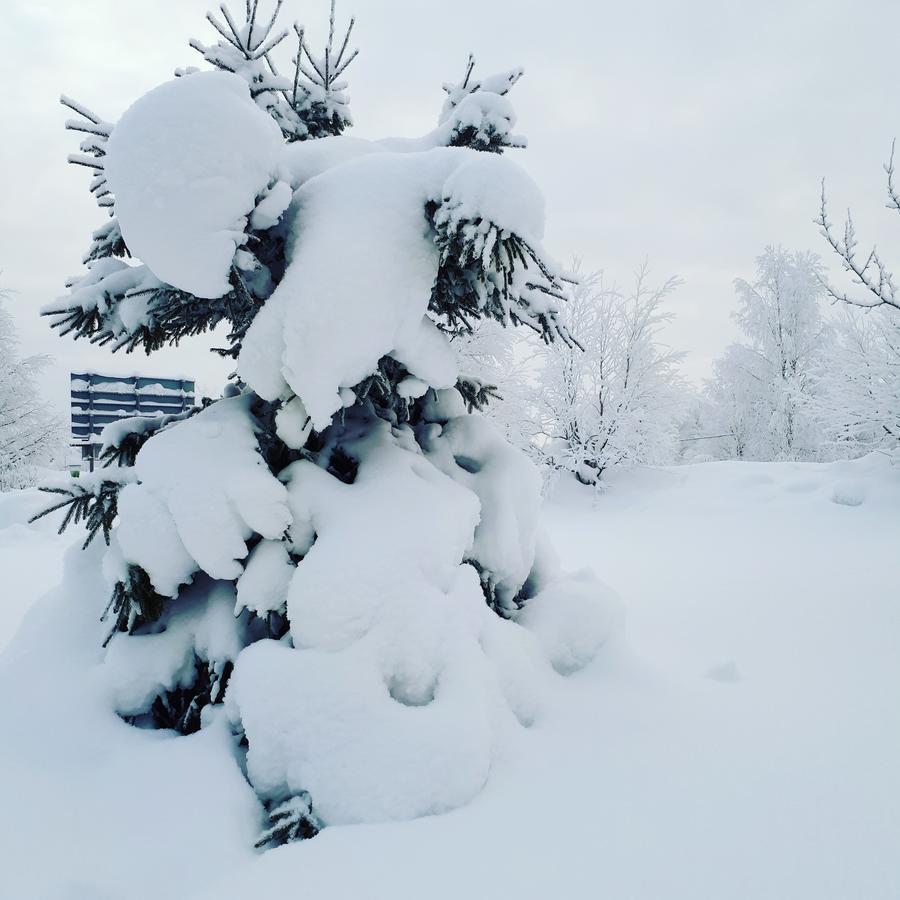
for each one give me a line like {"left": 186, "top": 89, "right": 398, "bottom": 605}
{"left": 226, "top": 419, "right": 613, "bottom": 824}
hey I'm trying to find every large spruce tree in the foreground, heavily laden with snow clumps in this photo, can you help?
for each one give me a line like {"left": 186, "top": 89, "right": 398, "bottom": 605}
{"left": 47, "top": 2, "right": 615, "bottom": 846}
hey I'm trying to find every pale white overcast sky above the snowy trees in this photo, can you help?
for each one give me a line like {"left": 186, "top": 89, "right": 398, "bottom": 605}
{"left": 0, "top": 0, "right": 900, "bottom": 402}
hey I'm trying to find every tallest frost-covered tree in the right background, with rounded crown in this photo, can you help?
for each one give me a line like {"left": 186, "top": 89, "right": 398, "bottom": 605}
{"left": 707, "top": 247, "right": 829, "bottom": 459}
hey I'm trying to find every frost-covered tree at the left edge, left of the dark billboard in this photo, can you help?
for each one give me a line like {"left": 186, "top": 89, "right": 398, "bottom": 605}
{"left": 0, "top": 292, "right": 62, "bottom": 491}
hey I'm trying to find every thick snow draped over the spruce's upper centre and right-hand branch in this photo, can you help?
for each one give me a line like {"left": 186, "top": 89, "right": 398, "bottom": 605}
{"left": 238, "top": 145, "right": 559, "bottom": 427}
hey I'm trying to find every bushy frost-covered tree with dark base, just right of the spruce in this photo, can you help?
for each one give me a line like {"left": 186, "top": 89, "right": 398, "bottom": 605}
{"left": 533, "top": 264, "right": 684, "bottom": 484}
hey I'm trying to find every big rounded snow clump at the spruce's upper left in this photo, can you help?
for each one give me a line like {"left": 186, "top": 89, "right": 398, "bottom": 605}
{"left": 106, "top": 72, "right": 282, "bottom": 298}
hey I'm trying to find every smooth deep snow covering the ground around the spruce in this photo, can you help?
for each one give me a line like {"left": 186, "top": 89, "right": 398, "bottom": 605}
{"left": 0, "top": 456, "right": 900, "bottom": 900}
